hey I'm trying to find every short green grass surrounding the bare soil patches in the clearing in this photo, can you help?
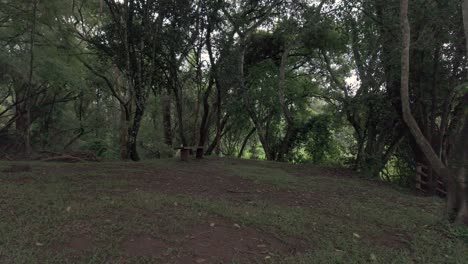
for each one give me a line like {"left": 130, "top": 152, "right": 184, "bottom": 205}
{"left": 0, "top": 161, "right": 468, "bottom": 264}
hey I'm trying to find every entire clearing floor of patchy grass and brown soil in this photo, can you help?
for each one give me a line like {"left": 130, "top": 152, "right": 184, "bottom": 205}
{"left": 0, "top": 159, "right": 468, "bottom": 263}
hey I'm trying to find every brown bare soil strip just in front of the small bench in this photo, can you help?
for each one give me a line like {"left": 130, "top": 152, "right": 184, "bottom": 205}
{"left": 108, "top": 159, "right": 326, "bottom": 206}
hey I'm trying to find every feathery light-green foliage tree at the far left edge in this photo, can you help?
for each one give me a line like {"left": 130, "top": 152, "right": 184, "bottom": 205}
{"left": 0, "top": 1, "right": 81, "bottom": 157}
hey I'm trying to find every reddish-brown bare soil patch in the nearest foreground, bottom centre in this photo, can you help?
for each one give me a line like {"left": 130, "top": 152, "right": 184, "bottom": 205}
{"left": 121, "top": 217, "right": 307, "bottom": 264}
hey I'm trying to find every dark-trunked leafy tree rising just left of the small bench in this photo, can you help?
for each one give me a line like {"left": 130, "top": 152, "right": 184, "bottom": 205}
{"left": 75, "top": 0, "right": 166, "bottom": 161}
